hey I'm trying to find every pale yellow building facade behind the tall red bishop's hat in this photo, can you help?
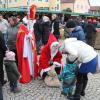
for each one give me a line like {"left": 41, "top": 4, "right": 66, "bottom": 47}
{"left": 2, "top": 0, "right": 60, "bottom": 11}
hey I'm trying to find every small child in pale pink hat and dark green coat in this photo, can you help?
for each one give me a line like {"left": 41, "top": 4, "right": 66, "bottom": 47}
{"left": 4, "top": 51, "right": 21, "bottom": 93}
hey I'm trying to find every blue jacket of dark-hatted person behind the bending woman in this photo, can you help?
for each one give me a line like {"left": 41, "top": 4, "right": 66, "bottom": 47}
{"left": 69, "top": 26, "right": 86, "bottom": 42}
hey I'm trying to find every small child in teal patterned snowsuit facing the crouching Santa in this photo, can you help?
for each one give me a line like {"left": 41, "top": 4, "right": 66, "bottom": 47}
{"left": 59, "top": 58, "right": 78, "bottom": 98}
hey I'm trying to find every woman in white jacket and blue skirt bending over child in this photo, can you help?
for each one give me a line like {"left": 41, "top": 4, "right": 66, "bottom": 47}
{"left": 63, "top": 38, "right": 98, "bottom": 100}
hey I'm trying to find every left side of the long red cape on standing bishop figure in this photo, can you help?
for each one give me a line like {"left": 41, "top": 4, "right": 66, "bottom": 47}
{"left": 16, "top": 25, "right": 31, "bottom": 83}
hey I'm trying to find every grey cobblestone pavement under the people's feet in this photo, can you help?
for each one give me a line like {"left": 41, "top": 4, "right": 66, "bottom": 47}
{"left": 3, "top": 53, "right": 100, "bottom": 100}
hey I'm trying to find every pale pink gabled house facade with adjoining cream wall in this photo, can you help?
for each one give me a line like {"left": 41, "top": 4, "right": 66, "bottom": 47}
{"left": 61, "top": 0, "right": 90, "bottom": 13}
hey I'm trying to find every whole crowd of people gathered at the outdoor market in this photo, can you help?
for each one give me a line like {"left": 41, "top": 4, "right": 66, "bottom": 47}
{"left": 0, "top": 14, "right": 100, "bottom": 100}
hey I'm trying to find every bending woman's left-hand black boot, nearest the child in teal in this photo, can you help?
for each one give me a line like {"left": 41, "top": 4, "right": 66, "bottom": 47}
{"left": 69, "top": 84, "right": 83, "bottom": 100}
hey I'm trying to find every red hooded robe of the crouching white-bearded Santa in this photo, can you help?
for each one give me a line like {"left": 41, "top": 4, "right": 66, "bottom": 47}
{"left": 39, "top": 33, "right": 62, "bottom": 74}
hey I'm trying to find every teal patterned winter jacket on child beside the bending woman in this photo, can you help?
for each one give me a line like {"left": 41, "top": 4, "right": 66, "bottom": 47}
{"left": 59, "top": 64, "right": 78, "bottom": 86}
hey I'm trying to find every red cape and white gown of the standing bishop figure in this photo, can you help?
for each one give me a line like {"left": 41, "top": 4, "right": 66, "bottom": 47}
{"left": 16, "top": 25, "right": 38, "bottom": 83}
